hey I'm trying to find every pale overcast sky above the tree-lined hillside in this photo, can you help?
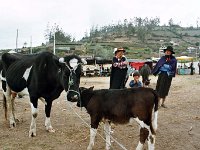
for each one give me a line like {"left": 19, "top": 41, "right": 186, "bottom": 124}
{"left": 0, "top": 0, "right": 200, "bottom": 49}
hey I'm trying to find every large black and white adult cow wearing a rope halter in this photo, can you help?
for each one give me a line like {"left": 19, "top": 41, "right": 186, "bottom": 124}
{"left": 2, "top": 52, "right": 86, "bottom": 137}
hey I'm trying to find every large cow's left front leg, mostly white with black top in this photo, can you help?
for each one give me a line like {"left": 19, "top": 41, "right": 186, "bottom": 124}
{"left": 29, "top": 99, "right": 38, "bottom": 137}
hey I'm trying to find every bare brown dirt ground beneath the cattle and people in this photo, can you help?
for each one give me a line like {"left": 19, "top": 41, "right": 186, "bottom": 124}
{"left": 0, "top": 75, "right": 200, "bottom": 150}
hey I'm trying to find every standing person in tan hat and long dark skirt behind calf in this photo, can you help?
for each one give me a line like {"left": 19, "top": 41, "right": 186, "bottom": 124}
{"left": 110, "top": 48, "right": 128, "bottom": 89}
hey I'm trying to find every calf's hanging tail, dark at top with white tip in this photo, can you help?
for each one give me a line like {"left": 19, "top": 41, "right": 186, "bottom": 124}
{"left": 150, "top": 90, "right": 158, "bottom": 134}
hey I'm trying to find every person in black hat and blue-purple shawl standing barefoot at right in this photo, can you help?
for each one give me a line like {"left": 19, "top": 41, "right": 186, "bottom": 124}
{"left": 152, "top": 46, "right": 177, "bottom": 108}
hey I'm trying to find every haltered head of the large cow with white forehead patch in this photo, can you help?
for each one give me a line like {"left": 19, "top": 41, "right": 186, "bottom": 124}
{"left": 59, "top": 55, "right": 86, "bottom": 102}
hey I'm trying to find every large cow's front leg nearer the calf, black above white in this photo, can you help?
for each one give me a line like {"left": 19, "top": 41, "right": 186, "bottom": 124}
{"left": 45, "top": 101, "right": 55, "bottom": 132}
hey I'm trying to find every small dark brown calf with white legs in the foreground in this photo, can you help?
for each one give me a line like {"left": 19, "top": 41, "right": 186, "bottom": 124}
{"left": 77, "top": 87, "right": 158, "bottom": 150}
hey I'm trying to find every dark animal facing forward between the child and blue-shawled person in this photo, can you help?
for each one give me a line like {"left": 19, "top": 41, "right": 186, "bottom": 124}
{"left": 140, "top": 64, "right": 151, "bottom": 87}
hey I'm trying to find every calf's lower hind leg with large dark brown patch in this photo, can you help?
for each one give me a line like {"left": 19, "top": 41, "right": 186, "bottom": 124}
{"left": 136, "top": 128, "right": 149, "bottom": 150}
